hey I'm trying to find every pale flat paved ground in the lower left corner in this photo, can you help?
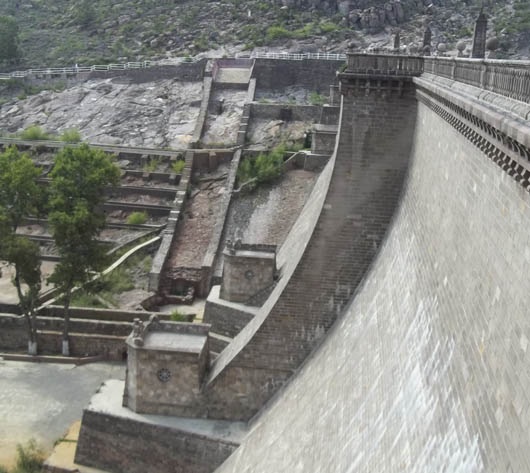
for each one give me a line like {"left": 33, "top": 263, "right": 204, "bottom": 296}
{"left": 0, "top": 360, "right": 125, "bottom": 465}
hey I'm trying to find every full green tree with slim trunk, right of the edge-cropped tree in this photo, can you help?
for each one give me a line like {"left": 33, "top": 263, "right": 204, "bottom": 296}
{"left": 49, "top": 144, "right": 120, "bottom": 356}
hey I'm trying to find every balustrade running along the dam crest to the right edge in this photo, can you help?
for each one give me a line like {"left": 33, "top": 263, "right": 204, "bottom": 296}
{"left": 424, "top": 57, "right": 530, "bottom": 103}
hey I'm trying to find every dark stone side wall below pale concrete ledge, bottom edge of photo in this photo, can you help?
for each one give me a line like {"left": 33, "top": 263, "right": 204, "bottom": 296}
{"left": 75, "top": 385, "right": 238, "bottom": 473}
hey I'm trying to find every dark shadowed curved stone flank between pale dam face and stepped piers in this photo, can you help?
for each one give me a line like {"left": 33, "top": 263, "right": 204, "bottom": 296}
{"left": 205, "top": 80, "right": 416, "bottom": 420}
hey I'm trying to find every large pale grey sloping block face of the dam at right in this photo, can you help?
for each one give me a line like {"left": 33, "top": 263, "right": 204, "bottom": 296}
{"left": 213, "top": 85, "right": 530, "bottom": 473}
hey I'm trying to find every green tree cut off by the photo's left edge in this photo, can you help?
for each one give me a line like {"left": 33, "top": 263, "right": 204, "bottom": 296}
{"left": 0, "top": 146, "right": 43, "bottom": 355}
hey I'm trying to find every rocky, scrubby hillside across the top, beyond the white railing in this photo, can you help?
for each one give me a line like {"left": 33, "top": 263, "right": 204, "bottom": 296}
{"left": 0, "top": 0, "right": 530, "bottom": 69}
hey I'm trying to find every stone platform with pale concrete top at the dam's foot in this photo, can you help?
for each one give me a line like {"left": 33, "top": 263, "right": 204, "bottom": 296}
{"left": 75, "top": 380, "right": 247, "bottom": 473}
